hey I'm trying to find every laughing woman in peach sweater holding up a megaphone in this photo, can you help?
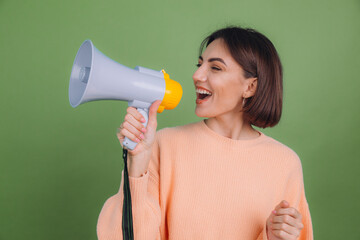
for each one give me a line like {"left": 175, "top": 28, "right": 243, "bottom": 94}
{"left": 97, "top": 27, "right": 313, "bottom": 240}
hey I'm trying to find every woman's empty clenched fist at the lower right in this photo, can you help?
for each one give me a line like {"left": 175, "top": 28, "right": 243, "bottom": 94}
{"left": 266, "top": 200, "right": 304, "bottom": 240}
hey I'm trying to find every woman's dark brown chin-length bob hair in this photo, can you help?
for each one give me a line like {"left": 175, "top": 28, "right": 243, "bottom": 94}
{"left": 199, "top": 26, "right": 283, "bottom": 128}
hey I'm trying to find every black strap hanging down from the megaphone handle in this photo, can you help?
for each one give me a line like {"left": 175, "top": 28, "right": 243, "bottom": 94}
{"left": 122, "top": 148, "right": 134, "bottom": 240}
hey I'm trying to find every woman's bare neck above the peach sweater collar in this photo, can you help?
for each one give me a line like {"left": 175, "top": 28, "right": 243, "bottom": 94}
{"left": 205, "top": 113, "right": 259, "bottom": 140}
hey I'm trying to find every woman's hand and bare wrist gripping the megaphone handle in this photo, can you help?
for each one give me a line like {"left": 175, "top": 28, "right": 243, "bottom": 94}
{"left": 117, "top": 100, "right": 161, "bottom": 177}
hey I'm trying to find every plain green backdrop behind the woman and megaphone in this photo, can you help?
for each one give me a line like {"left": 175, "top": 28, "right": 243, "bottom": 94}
{"left": 0, "top": 0, "right": 360, "bottom": 240}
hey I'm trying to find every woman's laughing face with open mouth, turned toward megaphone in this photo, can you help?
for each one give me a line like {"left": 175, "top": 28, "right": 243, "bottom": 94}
{"left": 193, "top": 39, "right": 253, "bottom": 118}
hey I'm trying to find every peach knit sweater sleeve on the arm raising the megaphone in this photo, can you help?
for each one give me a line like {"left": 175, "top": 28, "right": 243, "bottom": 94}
{"left": 97, "top": 136, "right": 161, "bottom": 240}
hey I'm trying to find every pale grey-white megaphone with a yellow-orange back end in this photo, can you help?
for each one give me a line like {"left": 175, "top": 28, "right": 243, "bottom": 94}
{"left": 69, "top": 40, "right": 182, "bottom": 150}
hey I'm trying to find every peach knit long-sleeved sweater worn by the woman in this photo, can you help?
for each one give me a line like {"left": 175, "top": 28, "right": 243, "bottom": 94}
{"left": 97, "top": 121, "right": 313, "bottom": 240}
